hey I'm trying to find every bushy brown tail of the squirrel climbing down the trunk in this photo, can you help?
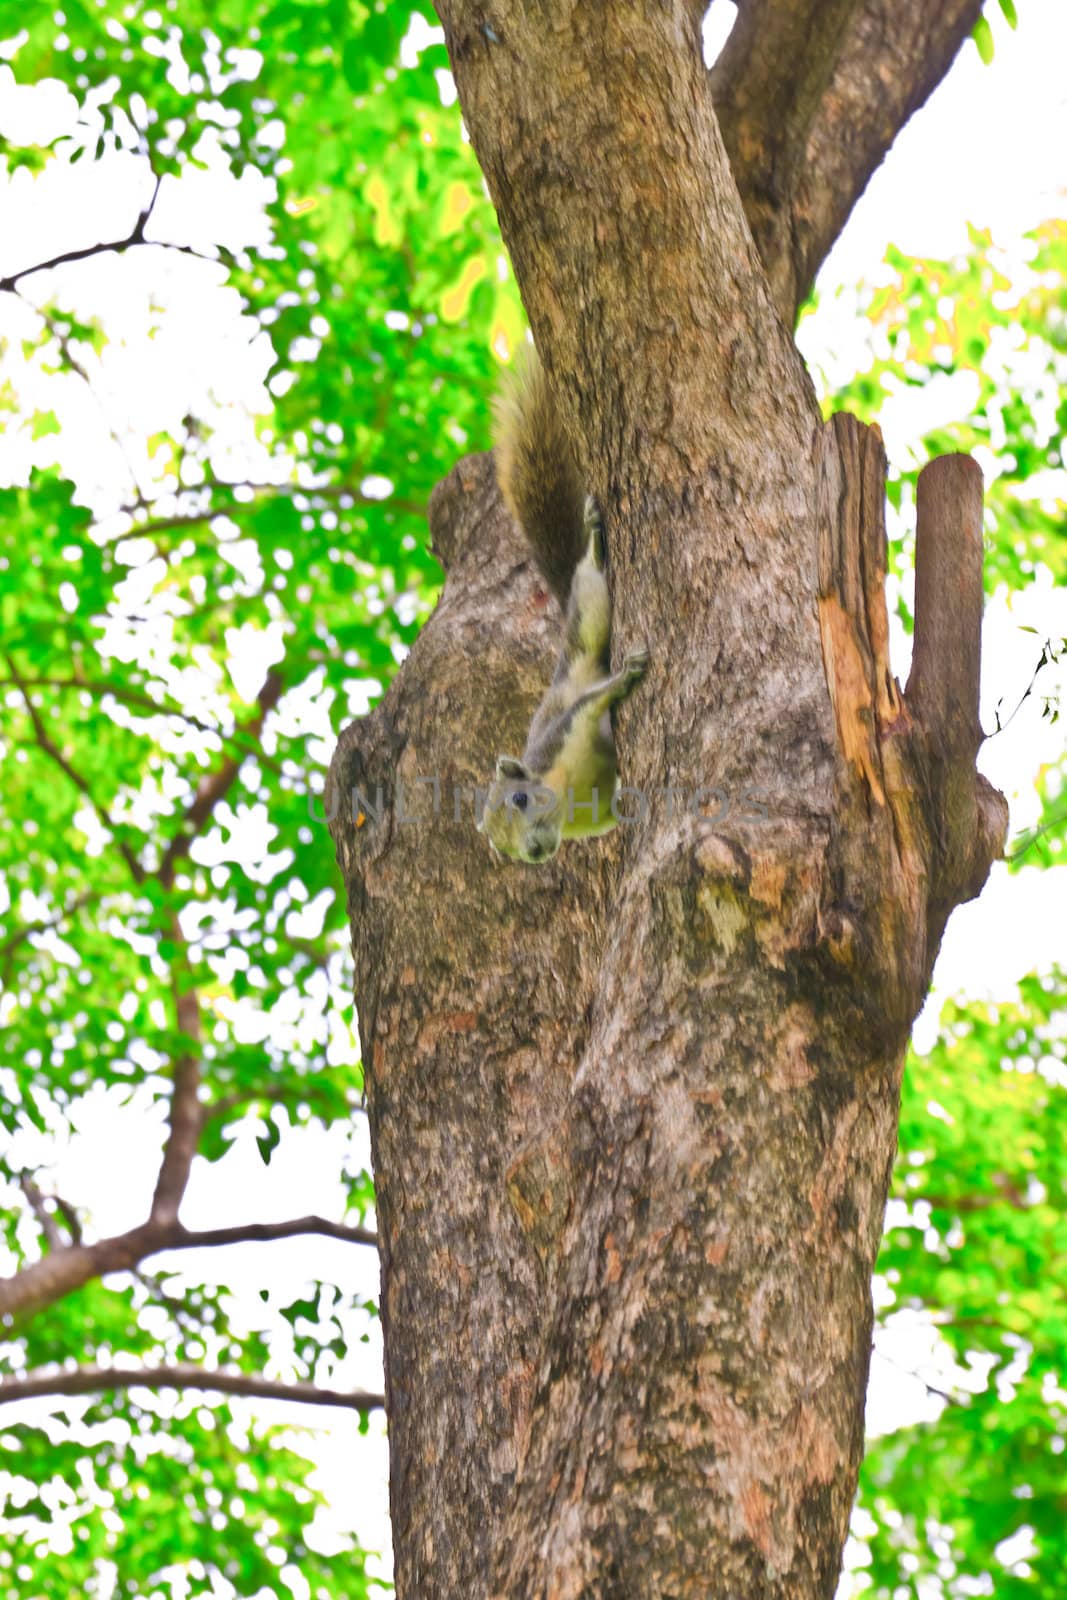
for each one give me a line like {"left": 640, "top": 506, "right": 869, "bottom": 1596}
{"left": 493, "top": 349, "right": 589, "bottom": 610}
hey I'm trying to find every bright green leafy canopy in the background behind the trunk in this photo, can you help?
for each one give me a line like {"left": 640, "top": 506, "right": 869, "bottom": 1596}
{"left": 0, "top": 0, "right": 1067, "bottom": 1600}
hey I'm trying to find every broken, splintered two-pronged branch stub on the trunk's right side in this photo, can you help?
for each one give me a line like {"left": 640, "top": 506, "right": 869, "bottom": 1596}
{"left": 817, "top": 414, "right": 1008, "bottom": 1037}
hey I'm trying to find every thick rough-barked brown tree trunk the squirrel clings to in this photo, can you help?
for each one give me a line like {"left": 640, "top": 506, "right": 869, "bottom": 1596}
{"left": 328, "top": 0, "right": 1006, "bottom": 1600}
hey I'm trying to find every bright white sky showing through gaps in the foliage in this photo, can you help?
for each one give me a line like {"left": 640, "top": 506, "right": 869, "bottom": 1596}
{"left": 0, "top": 0, "right": 1067, "bottom": 1600}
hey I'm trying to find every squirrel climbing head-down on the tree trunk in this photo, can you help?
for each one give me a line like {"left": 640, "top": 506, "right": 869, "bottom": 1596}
{"left": 478, "top": 350, "right": 648, "bottom": 864}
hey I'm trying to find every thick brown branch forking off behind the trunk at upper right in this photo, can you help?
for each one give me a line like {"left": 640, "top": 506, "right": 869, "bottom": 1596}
{"left": 712, "top": 0, "right": 982, "bottom": 326}
